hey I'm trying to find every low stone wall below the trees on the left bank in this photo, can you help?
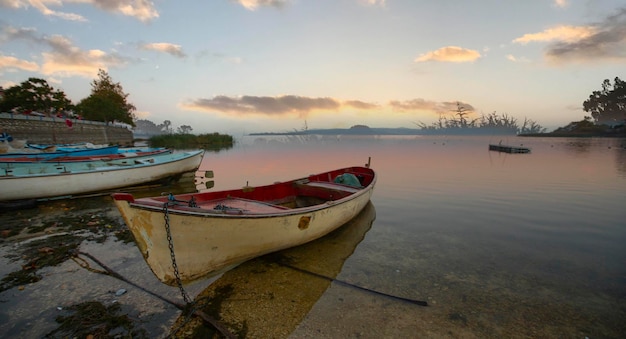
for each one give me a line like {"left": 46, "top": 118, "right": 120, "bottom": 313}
{"left": 0, "top": 113, "right": 133, "bottom": 146}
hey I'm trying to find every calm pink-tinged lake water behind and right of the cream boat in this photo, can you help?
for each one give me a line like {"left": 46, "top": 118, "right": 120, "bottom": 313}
{"left": 202, "top": 136, "right": 626, "bottom": 338}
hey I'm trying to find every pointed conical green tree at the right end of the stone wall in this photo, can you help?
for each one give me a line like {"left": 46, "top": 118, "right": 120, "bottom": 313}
{"left": 76, "top": 69, "right": 136, "bottom": 126}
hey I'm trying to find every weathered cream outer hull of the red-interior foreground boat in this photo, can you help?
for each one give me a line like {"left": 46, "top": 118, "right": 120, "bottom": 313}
{"left": 114, "top": 166, "right": 375, "bottom": 285}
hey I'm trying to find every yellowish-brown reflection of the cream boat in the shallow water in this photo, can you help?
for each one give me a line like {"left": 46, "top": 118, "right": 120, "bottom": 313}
{"left": 173, "top": 202, "right": 376, "bottom": 338}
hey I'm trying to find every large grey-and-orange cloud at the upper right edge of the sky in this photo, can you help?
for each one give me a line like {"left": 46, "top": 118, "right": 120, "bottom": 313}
{"left": 513, "top": 8, "right": 626, "bottom": 64}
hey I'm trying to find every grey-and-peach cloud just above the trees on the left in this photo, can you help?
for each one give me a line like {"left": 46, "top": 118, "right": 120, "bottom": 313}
{"left": 0, "top": 27, "right": 127, "bottom": 78}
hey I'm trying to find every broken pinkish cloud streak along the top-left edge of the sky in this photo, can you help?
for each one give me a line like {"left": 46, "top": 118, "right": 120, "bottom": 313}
{"left": 0, "top": 0, "right": 159, "bottom": 22}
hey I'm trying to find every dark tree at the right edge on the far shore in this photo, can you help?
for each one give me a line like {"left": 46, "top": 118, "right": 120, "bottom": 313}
{"left": 583, "top": 77, "right": 626, "bottom": 125}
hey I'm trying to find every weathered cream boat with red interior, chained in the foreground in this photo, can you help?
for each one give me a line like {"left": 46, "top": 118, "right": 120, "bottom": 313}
{"left": 113, "top": 166, "right": 376, "bottom": 285}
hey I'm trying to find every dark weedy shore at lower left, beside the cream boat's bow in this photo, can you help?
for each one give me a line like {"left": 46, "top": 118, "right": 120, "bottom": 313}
{"left": 0, "top": 179, "right": 208, "bottom": 338}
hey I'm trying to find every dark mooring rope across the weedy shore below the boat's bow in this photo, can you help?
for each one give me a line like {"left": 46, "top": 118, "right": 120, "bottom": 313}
{"left": 71, "top": 251, "right": 237, "bottom": 339}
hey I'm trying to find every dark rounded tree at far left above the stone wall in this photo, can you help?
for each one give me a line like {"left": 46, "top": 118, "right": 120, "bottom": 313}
{"left": 0, "top": 78, "right": 73, "bottom": 114}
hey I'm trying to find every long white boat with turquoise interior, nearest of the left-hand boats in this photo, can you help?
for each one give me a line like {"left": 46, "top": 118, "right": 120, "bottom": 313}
{"left": 0, "top": 150, "right": 204, "bottom": 201}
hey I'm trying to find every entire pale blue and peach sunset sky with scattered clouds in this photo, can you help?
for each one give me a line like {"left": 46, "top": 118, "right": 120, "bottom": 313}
{"left": 0, "top": 0, "right": 626, "bottom": 135}
